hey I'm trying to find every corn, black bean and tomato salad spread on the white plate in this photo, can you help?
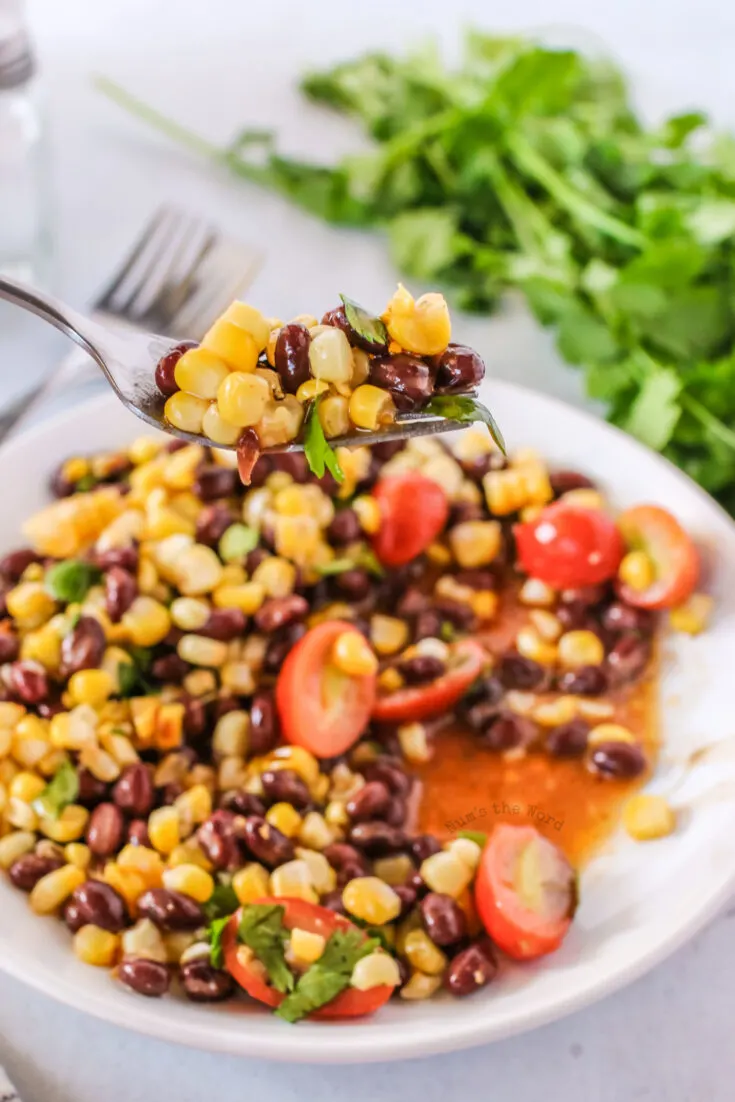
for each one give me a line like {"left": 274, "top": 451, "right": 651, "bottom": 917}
{"left": 0, "top": 425, "right": 710, "bottom": 1022}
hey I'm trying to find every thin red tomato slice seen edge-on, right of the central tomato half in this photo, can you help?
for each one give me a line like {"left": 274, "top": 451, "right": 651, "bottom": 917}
{"left": 372, "top": 639, "right": 487, "bottom": 723}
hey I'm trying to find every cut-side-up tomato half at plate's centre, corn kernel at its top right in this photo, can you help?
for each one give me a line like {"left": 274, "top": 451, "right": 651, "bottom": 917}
{"left": 275, "top": 620, "right": 376, "bottom": 758}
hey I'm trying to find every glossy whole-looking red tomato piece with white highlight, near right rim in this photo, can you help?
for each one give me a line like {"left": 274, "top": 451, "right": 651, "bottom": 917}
{"left": 515, "top": 501, "right": 624, "bottom": 590}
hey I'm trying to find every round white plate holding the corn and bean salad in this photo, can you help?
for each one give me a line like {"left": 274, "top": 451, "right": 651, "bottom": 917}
{"left": 0, "top": 383, "right": 735, "bottom": 1062}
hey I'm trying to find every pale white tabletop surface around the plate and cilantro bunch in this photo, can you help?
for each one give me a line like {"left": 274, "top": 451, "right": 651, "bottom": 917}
{"left": 0, "top": 0, "right": 735, "bottom": 1102}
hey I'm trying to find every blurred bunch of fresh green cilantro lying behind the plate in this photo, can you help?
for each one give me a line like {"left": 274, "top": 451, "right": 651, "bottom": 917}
{"left": 97, "top": 32, "right": 735, "bottom": 512}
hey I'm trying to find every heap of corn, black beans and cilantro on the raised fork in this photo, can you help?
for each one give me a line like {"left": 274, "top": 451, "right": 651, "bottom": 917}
{"left": 155, "top": 285, "right": 491, "bottom": 483}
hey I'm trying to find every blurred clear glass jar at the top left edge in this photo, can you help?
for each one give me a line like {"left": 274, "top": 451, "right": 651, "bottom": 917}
{"left": 0, "top": 0, "right": 51, "bottom": 283}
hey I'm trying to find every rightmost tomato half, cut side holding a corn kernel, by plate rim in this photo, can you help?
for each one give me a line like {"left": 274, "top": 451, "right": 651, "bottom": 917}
{"left": 617, "top": 505, "right": 700, "bottom": 608}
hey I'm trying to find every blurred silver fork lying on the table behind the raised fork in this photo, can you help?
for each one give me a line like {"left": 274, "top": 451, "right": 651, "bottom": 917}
{"left": 0, "top": 206, "right": 262, "bottom": 443}
